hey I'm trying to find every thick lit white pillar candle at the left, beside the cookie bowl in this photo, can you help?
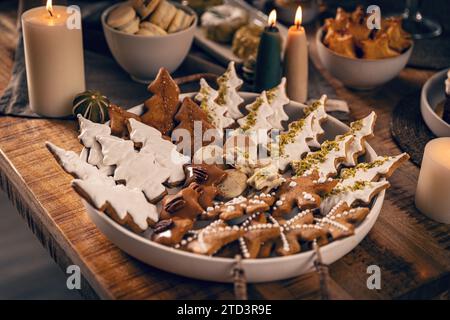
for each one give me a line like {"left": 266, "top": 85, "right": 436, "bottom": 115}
{"left": 22, "top": 1, "right": 85, "bottom": 117}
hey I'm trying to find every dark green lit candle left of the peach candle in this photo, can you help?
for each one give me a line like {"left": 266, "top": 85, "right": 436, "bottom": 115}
{"left": 255, "top": 10, "right": 282, "bottom": 92}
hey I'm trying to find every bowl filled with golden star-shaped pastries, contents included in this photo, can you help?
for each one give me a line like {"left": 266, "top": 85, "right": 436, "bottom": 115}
{"left": 316, "top": 6, "right": 413, "bottom": 90}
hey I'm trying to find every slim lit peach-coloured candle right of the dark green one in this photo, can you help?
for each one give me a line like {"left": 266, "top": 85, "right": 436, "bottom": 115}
{"left": 284, "top": 6, "right": 308, "bottom": 103}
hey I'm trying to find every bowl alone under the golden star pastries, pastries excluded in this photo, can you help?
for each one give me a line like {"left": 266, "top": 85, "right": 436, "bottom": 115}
{"left": 316, "top": 28, "right": 414, "bottom": 90}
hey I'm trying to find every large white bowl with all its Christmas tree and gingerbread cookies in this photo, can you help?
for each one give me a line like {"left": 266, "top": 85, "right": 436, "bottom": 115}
{"left": 47, "top": 63, "right": 408, "bottom": 282}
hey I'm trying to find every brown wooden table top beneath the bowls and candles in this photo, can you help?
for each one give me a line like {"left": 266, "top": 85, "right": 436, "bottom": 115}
{"left": 0, "top": 3, "right": 450, "bottom": 299}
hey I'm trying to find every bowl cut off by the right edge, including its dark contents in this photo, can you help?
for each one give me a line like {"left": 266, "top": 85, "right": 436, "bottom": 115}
{"left": 420, "top": 69, "right": 450, "bottom": 137}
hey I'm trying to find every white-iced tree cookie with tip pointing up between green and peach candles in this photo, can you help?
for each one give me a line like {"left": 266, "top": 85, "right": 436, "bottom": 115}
{"left": 266, "top": 78, "right": 289, "bottom": 130}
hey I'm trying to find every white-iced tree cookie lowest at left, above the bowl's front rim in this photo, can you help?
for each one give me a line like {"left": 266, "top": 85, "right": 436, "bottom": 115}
{"left": 72, "top": 179, "right": 159, "bottom": 233}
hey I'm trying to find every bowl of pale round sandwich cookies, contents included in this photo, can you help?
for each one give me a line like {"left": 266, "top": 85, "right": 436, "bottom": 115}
{"left": 101, "top": 0, "right": 197, "bottom": 83}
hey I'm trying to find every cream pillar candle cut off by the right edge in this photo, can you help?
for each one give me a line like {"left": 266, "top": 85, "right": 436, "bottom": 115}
{"left": 416, "top": 138, "right": 450, "bottom": 223}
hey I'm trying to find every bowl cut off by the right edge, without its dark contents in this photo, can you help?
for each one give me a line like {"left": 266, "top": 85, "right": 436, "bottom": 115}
{"left": 420, "top": 69, "right": 450, "bottom": 137}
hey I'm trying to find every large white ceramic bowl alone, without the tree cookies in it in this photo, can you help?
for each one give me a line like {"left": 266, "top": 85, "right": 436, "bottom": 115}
{"left": 83, "top": 92, "right": 385, "bottom": 283}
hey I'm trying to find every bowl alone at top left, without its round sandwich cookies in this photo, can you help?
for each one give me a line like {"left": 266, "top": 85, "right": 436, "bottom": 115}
{"left": 101, "top": 3, "right": 198, "bottom": 83}
